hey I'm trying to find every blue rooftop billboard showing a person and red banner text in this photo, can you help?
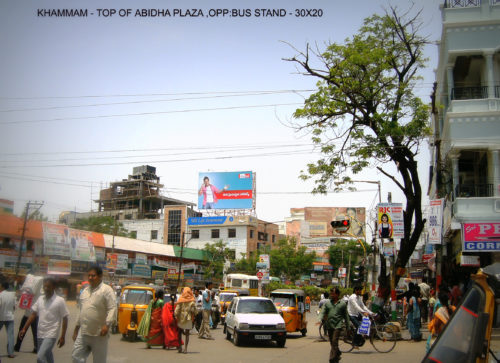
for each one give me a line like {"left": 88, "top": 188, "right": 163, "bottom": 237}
{"left": 198, "top": 171, "right": 254, "bottom": 209}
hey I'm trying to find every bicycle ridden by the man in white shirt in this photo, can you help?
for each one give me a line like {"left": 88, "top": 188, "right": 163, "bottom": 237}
{"left": 339, "top": 316, "right": 397, "bottom": 353}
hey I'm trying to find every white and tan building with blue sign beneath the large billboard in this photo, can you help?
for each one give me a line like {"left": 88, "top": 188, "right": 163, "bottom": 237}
{"left": 186, "top": 216, "right": 280, "bottom": 259}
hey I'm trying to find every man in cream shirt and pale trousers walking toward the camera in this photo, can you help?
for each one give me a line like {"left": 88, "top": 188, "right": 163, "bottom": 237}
{"left": 72, "top": 266, "right": 116, "bottom": 363}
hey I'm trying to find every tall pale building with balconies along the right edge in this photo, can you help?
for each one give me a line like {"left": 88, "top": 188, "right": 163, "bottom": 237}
{"left": 428, "top": 0, "right": 500, "bottom": 276}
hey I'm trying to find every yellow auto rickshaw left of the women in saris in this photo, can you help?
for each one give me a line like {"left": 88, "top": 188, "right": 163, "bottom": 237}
{"left": 118, "top": 285, "right": 155, "bottom": 342}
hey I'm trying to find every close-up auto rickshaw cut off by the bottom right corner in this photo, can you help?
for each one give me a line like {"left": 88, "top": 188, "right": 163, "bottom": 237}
{"left": 422, "top": 262, "right": 500, "bottom": 363}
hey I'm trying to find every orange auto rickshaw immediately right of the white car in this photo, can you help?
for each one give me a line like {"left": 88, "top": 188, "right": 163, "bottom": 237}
{"left": 271, "top": 289, "right": 307, "bottom": 336}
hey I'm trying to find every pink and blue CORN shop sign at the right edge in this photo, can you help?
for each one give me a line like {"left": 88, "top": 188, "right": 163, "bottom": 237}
{"left": 462, "top": 222, "right": 500, "bottom": 252}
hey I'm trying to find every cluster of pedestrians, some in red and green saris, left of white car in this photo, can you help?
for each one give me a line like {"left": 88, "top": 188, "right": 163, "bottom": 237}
{"left": 138, "top": 283, "right": 213, "bottom": 353}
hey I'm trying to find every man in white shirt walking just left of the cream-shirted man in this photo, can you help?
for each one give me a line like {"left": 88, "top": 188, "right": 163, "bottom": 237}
{"left": 19, "top": 277, "right": 69, "bottom": 363}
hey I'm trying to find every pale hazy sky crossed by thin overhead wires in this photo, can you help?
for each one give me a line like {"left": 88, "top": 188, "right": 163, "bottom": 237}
{"left": 0, "top": 0, "right": 442, "bottom": 226}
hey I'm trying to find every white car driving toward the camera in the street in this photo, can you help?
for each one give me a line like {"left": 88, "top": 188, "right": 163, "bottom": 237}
{"left": 224, "top": 296, "right": 286, "bottom": 348}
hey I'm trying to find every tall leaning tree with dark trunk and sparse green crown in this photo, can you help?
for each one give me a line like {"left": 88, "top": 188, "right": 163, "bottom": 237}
{"left": 288, "top": 8, "right": 430, "bottom": 298}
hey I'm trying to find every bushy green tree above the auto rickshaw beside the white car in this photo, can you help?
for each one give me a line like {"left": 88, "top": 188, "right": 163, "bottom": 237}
{"left": 269, "top": 237, "right": 316, "bottom": 281}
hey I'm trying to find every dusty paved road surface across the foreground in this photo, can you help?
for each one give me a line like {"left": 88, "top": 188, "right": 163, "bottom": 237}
{"left": 0, "top": 302, "right": 425, "bottom": 363}
